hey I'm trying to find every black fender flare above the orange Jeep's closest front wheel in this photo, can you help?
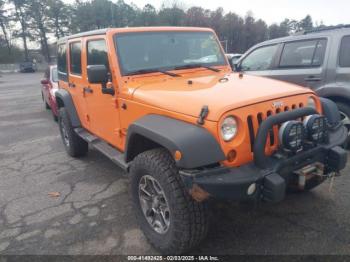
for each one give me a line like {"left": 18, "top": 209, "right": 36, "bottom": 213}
{"left": 125, "top": 114, "right": 225, "bottom": 169}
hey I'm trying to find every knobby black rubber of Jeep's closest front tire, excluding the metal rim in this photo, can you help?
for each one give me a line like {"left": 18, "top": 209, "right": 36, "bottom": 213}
{"left": 130, "top": 148, "right": 209, "bottom": 254}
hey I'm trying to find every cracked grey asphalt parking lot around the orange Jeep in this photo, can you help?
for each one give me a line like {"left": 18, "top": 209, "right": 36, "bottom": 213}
{"left": 0, "top": 73, "right": 350, "bottom": 255}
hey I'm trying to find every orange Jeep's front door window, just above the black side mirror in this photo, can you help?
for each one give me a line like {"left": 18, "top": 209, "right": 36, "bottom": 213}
{"left": 87, "top": 39, "right": 108, "bottom": 68}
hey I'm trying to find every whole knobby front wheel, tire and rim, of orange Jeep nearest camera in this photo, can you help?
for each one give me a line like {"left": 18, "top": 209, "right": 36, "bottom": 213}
{"left": 130, "top": 149, "right": 209, "bottom": 254}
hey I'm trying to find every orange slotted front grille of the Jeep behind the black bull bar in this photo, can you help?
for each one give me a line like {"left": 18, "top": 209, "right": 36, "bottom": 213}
{"left": 247, "top": 103, "right": 303, "bottom": 152}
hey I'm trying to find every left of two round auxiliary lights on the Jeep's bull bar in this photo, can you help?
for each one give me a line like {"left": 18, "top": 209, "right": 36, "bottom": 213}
{"left": 278, "top": 120, "right": 305, "bottom": 152}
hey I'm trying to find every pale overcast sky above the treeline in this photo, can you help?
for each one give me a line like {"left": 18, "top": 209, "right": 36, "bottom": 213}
{"left": 64, "top": 0, "right": 350, "bottom": 25}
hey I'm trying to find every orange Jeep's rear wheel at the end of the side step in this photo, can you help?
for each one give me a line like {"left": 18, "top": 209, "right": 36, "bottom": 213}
{"left": 58, "top": 107, "right": 88, "bottom": 157}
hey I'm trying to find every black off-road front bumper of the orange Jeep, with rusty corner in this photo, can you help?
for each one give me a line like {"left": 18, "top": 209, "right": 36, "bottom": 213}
{"left": 180, "top": 106, "right": 348, "bottom": 202}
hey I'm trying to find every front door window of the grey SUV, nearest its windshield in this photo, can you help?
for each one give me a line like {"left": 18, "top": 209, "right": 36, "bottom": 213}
{"left": 240, "top": 45, "right": 277, "bottom": 71}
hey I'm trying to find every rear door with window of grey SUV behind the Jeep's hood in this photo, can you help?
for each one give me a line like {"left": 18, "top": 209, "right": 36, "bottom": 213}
{"left": 269, "top": 38, "right": 328, "bottom": 89}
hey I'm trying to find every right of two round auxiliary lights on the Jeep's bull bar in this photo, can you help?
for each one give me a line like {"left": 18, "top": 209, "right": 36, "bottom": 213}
{"left": 304, "top": 114, "right": 328, "bottom": 143}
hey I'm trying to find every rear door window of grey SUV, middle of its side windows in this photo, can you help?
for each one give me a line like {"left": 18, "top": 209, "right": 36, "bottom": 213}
{"left": 279, "top": 39, "right": 327, "bottom": 68}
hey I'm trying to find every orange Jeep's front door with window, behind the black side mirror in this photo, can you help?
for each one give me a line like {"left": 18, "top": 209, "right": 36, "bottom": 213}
{"left": 83, "top": 36, "right": 120, "bottom": 147}
